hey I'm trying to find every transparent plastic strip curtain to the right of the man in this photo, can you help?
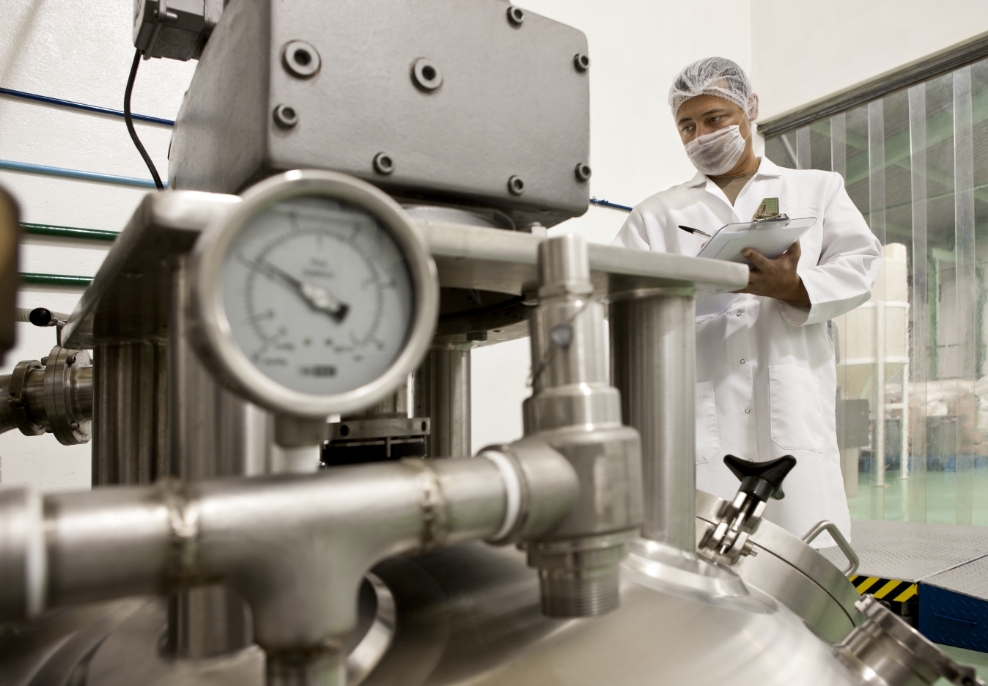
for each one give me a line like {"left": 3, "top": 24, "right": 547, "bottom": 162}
{"left": 765, "top": 61, "right": 988, "bottom": 526}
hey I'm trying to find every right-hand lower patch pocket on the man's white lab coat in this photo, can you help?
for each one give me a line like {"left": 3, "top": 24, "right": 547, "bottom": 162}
{"left": 768, "top": 364, "right": 823, "bottom": 452}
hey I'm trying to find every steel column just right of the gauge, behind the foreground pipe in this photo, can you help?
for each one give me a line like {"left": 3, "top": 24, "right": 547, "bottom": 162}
{"left": 413, "top": 345, "right": 473, "bottom": 457}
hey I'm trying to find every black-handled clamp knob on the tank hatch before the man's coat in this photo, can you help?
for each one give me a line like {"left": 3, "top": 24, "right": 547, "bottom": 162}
{"left": 697, "top": 455, "right": 796, "bottom": 564}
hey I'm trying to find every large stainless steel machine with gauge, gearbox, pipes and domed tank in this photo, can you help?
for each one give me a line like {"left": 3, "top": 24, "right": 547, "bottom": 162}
{"left": 0, "top": 0, "right": 982, "bottom": 686}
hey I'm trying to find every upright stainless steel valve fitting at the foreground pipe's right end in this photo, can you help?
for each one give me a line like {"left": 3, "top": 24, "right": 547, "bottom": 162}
{"left": 524, "top": 234, "right": 641, "bottom": 617}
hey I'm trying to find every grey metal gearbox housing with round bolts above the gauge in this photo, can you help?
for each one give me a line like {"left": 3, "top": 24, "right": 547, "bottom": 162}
{"left": 169, "top": 0, "right": 590, "bottom": 226}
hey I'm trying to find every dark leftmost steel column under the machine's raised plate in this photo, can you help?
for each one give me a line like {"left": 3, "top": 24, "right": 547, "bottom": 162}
{"left": 93, "top": 341, "right": 169, "bottom": 486}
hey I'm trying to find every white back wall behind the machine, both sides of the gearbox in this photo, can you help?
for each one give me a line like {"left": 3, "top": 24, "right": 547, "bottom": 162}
{"left": 0, "top": 0, "right": 751, "bottom": 490}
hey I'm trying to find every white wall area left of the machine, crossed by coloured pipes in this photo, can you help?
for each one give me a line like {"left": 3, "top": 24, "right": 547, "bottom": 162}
{"left": 0, "top": 0, "right": 195, "bottom": 490}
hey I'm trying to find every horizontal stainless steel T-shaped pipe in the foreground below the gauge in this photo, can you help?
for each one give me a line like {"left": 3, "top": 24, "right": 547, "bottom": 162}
{"left": 0, "top": 441, "right": 580, "bottom": 686}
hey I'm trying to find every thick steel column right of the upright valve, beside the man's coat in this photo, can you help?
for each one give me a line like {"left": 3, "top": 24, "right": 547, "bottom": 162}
{"left": 610, "top": 293, "right": 696, "bottom": 552}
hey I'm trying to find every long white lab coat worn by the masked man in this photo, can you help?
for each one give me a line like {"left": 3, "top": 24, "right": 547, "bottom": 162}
{"left": 614, "top": 158, "right": 881, "bottom": 547}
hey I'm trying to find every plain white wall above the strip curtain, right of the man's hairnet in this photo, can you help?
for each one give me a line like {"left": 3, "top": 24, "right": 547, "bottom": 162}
{"left": 751, "top": 0, "right": 988, "bottom": 119}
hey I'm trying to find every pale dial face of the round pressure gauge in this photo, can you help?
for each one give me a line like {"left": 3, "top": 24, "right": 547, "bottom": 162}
{"left": 222, "top": 196, "right": 415, "bottom": 396}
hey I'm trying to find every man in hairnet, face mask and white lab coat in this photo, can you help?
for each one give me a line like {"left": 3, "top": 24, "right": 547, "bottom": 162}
{"left": 614, "top": 57, "right": 881, "bottom": 547}
